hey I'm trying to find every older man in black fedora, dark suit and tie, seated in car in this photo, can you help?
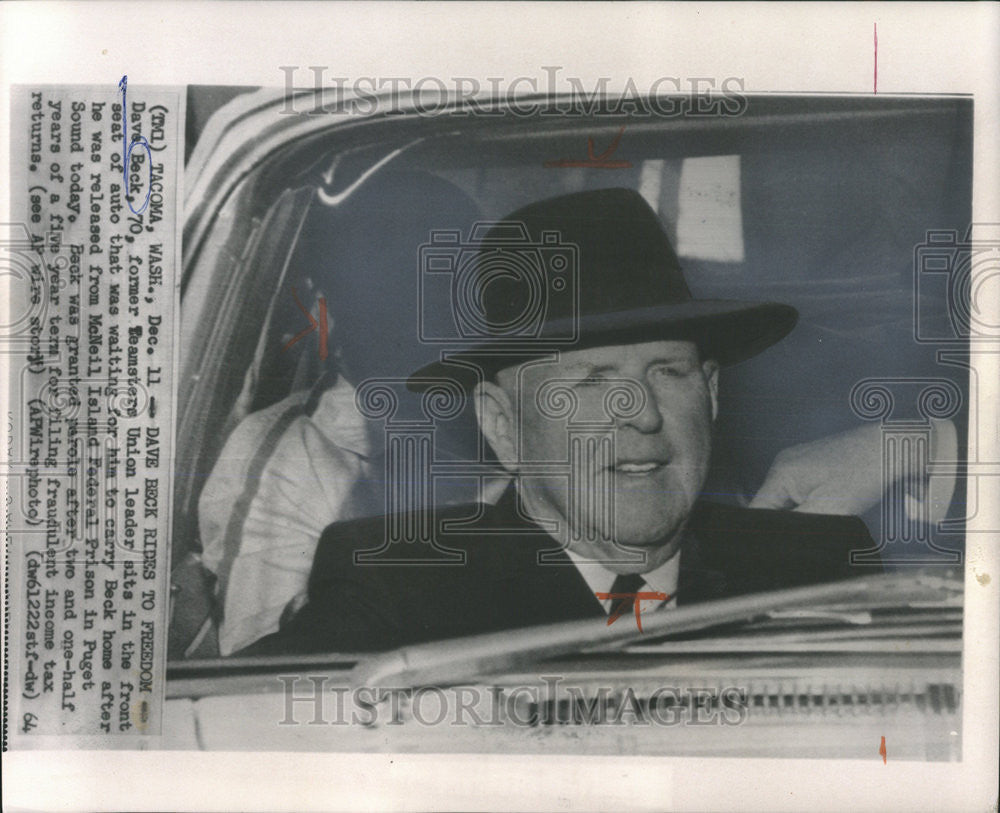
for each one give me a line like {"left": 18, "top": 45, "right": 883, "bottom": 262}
{"left": 246, "top": 189, "right": 873, "bottom": 652}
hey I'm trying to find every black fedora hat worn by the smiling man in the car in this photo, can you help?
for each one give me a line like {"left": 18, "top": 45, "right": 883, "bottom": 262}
{"left": 409, "top": 189, "right": 798, "bottom": 391}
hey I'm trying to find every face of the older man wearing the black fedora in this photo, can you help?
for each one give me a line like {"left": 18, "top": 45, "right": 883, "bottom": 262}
{"left": 477, "top": 340, "right": 718, "bottom": 572}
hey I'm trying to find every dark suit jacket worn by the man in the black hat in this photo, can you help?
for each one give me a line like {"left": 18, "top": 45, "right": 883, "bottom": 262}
{"left": 241, "top": 487, "right": 874, "bottom": 654}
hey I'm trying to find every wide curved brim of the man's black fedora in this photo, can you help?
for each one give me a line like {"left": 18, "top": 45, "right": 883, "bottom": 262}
{"left": 407, "top": 299, "right": 799, "bottom": 392}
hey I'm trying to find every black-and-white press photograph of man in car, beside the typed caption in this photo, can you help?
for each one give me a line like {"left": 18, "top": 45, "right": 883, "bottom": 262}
{"left": 168, "top": 85, "right": 972, "bottom": 744}
